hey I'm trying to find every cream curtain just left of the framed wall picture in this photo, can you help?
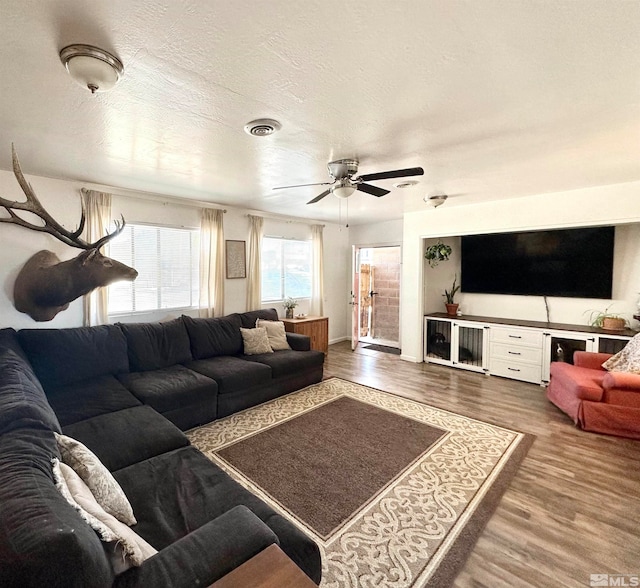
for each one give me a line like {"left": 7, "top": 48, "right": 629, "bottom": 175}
{"left": 199, "top": 208, "right": 224, "bottom": 318}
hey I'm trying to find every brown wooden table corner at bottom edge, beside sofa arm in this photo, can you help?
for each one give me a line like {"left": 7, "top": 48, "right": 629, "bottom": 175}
{"left": 209, "top": 543, "right": 318, "bottom": 588}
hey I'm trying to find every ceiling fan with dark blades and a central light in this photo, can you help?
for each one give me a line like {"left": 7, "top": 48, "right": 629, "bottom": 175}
{"left": 273, "top": 159, "right": 424, "bottom": 204}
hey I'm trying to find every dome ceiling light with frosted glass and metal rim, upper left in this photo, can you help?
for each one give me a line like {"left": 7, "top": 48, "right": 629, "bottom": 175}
{"left": 60, "top": 44, "right": 124, "bottom": 94}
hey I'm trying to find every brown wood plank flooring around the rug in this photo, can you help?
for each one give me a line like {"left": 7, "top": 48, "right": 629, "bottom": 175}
{"left": 325, "top": 342, "right": 640, "bottom": 588}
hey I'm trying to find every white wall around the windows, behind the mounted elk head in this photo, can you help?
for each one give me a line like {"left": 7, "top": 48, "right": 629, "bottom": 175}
{"left": 0, "top": 171, "right": 350, "bottom": 341}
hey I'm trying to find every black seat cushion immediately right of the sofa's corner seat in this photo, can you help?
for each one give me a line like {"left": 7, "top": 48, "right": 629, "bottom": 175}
{"left": 119, "top": 365, "right": 218, "bottom": 413}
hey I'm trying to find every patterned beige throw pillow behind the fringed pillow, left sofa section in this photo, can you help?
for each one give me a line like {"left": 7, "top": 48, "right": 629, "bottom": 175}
{"left": 55, "top": 433, "right": 137, "bottom": 525}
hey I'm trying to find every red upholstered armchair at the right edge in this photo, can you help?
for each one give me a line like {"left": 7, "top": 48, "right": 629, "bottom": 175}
{"left": 547, "top": 351, "right": 640, "bottom": 439}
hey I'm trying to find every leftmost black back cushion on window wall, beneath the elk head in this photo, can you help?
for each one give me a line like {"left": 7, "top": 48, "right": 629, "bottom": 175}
{"left": 18, "top": 325, "right": 129, "bottom": 392}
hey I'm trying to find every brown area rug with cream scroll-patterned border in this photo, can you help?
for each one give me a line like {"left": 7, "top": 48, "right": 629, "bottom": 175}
{"left": 188, "top": 378, "right": 533, "bottom": 588}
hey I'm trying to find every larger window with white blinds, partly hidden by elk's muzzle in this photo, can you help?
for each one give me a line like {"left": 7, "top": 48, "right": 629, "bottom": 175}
{"left": 109, "top": 224, "right": 200, "bottom": 315}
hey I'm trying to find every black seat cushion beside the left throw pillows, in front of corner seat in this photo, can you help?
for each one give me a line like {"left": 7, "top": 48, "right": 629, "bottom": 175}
{"left": 63, "top": 405, "right": 189, "bottom": 472}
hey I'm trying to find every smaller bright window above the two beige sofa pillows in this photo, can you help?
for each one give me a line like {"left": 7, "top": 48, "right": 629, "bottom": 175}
{"left": 261, "top": 237, "right": 312, "bottom": 302}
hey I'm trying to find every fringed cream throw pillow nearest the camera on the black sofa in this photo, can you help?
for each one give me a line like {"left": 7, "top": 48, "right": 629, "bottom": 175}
{"left": 51, "top": 458, "right": 158, "bottom": 574}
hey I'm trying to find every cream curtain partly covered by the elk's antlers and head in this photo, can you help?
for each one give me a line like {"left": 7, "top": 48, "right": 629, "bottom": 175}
{"left": 82, "top": 190, "right": 111, "bottom": 327}
